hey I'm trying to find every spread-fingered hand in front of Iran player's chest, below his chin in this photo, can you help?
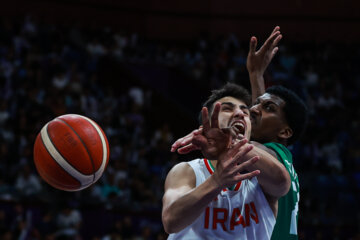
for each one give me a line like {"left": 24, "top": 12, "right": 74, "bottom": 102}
{"left": 211, "top": 139, "right": 260, "bottom": 188}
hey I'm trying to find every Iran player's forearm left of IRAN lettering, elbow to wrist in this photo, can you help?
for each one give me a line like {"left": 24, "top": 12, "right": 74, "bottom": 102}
{"left": 162, "top": 177, "right": 221, "bottom": 233}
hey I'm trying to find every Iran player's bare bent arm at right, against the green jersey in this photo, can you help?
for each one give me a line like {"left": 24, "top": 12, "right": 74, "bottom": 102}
{"left": 243, "top": 146, "right": 291, "bottom": 197}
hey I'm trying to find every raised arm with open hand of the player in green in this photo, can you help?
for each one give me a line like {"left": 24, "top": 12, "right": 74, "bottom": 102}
{"left": 246, "top": 26, "right": 282, "bottom": 102}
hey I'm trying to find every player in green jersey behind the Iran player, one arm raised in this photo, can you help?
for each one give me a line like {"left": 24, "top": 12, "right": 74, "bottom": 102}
{"left": 172, "top": 27, "right": 307, "bottom": 240}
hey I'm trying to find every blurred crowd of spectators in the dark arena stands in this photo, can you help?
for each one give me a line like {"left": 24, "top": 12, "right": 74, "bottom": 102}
{"left": 0, "top": 16, "right": 360, "bottom": 240}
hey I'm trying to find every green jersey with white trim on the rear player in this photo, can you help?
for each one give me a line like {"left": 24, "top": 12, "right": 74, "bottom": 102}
{"left": 264, "top": 142, "right": 300, "bottom": 240}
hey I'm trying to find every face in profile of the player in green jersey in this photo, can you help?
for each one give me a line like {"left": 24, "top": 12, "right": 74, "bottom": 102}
{"left": 250, "top": 93, "right": 287, "bottom": 143}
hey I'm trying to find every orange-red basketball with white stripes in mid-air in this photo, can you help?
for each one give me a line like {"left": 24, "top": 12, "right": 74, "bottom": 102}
{"left": 34, "top": 114, "right": 109, "bottom": 191}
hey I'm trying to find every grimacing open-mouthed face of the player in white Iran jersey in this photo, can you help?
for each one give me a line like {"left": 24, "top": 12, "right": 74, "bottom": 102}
{"left": 217, "top": 97, "right": 251, "bottom": 139}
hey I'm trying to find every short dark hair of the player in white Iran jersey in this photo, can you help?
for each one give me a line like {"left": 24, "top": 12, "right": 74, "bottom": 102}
{"left": 199, "top": 83, "right": 251, "bottom": 124}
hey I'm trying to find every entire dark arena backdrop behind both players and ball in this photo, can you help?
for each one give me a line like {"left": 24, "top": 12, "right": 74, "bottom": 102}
{"left": 0, "top": 0, "right": 360, "bottom": 240}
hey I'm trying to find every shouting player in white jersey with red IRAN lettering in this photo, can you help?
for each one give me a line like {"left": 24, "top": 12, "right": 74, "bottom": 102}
{"left": 162, "top": 84, "right": 290, "bottom": 239}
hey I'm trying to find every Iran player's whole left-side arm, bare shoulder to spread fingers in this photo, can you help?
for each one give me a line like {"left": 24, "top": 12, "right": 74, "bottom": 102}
{"left": 162, "top": 141, "right": 260, "bottom": 233}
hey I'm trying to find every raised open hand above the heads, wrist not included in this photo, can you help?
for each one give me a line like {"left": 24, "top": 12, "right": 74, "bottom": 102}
{"left": 246, "top": 26, "right": 282, "bottom": 76}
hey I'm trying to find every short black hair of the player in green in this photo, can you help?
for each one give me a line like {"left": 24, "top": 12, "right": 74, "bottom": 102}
{"left": 265, "top": 85, "right": 308, "bottom": 145}
